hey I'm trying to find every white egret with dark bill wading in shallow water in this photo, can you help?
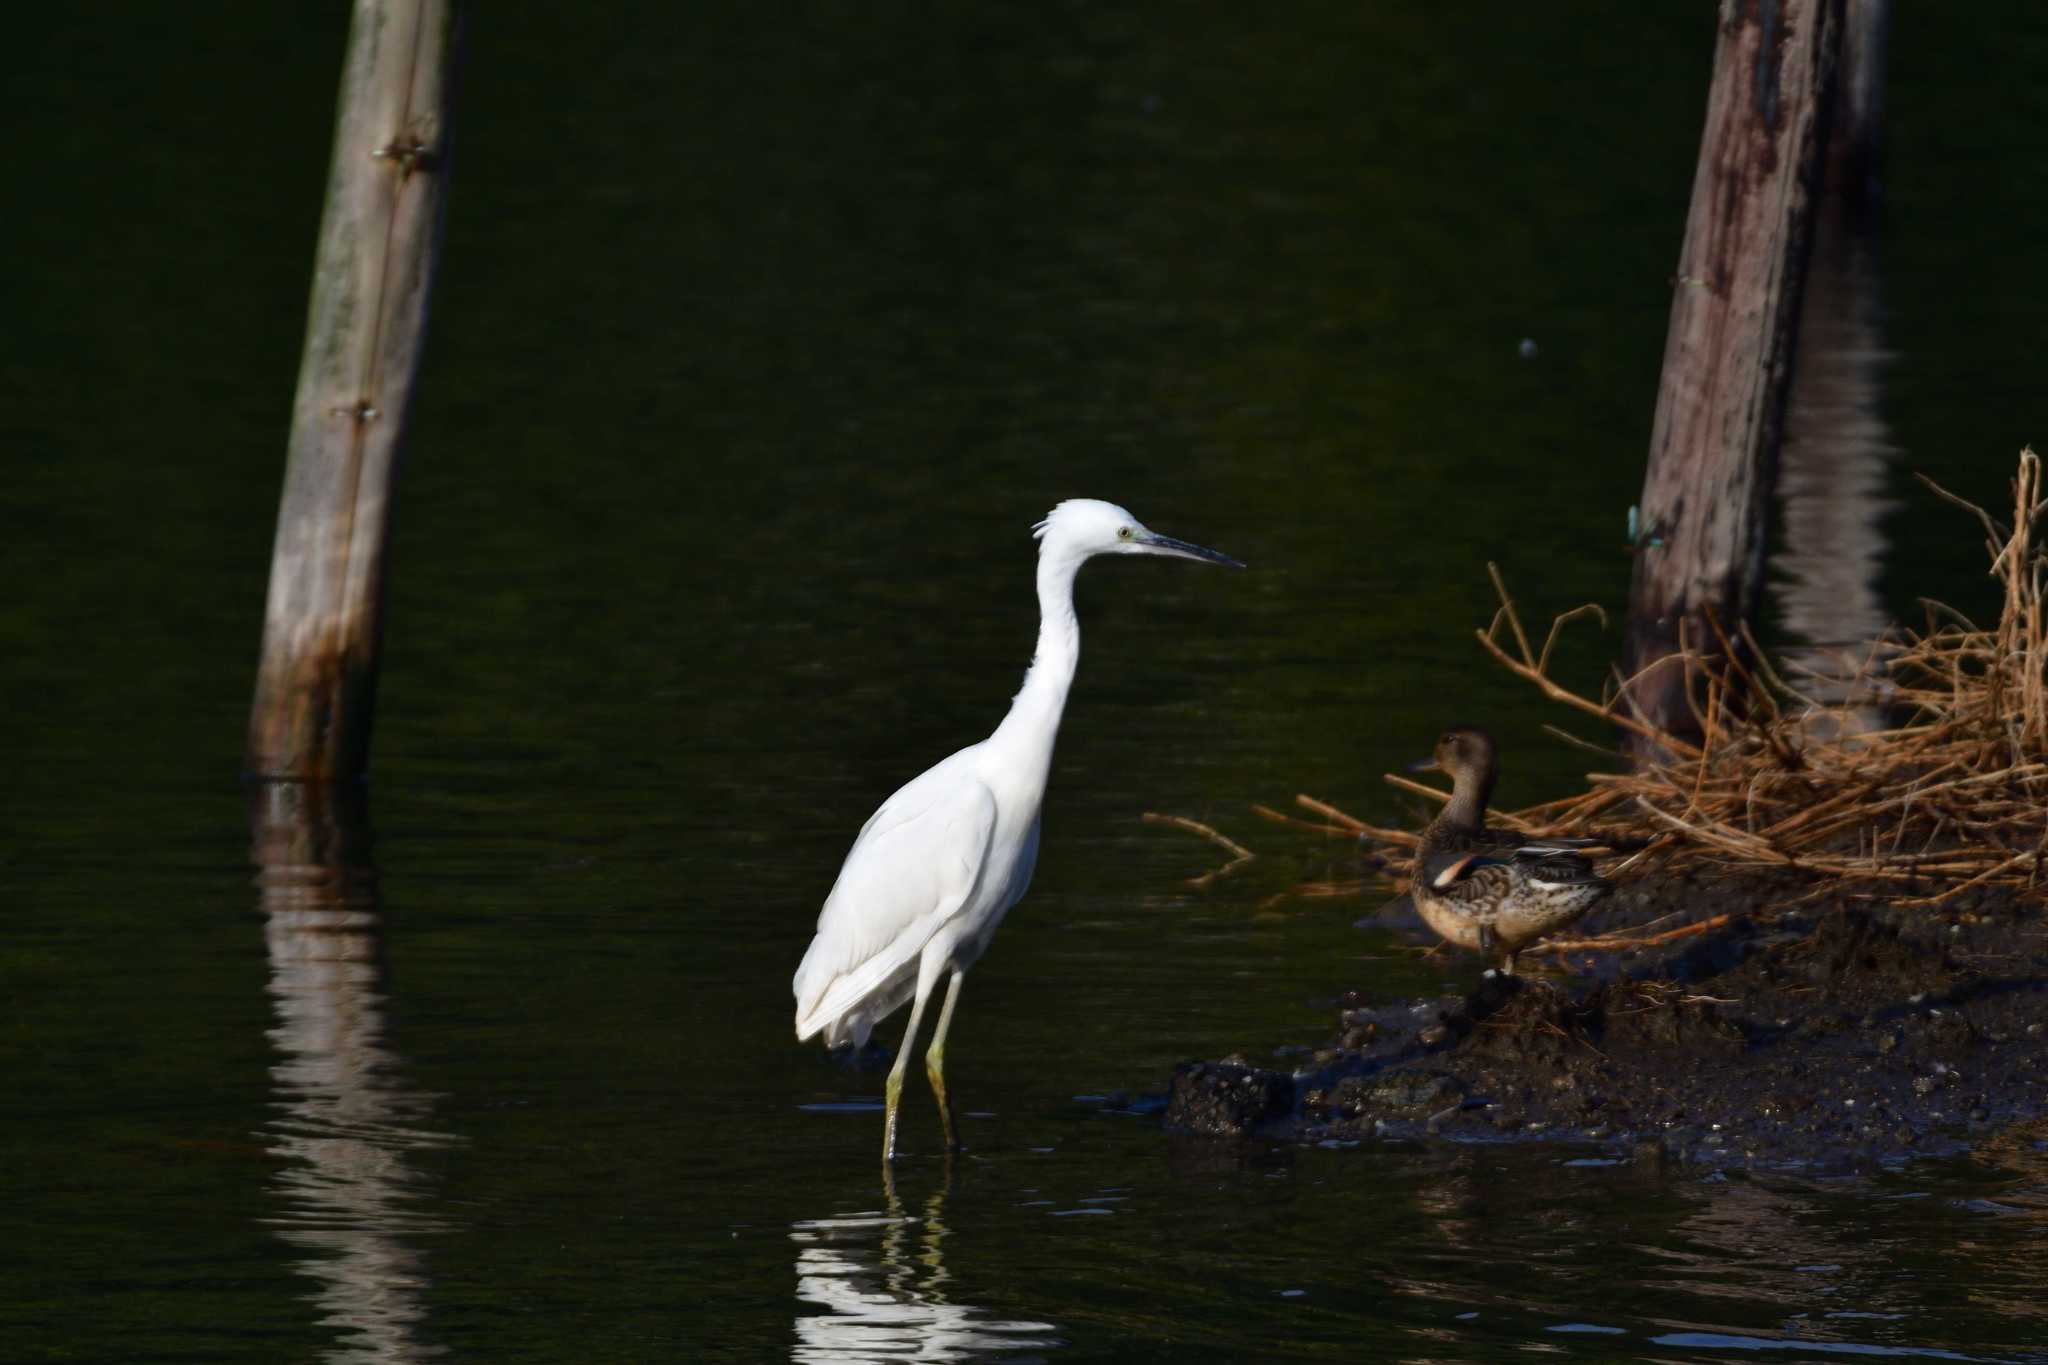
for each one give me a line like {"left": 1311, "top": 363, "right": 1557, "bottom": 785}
{"left": 791, "top": 497, "right": 1243, "bottom": 1160}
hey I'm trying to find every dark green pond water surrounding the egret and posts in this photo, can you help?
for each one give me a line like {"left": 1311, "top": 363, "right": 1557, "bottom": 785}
{"left": 12, "top": 4, "right": 2048, "bottom": 1361}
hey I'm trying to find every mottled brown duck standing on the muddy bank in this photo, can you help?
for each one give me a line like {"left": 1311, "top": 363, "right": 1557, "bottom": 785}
{"left": 1409, "top": 726, "right": 1614, "bottom": 972}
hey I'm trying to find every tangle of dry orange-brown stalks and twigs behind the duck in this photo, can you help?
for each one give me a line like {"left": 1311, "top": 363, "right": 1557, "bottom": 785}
{"left": 1155, "top": 450, "right": 2048, "bottom": 905}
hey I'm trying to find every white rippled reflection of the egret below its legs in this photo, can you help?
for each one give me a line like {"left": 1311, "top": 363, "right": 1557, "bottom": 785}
{"left": 788, "top": 1173, "right": 1065, "bottom": 1365}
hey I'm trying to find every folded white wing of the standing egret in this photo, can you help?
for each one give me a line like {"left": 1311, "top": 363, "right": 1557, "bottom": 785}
{"left": 791, "top": 749, "right": 995, "bottom": 1040}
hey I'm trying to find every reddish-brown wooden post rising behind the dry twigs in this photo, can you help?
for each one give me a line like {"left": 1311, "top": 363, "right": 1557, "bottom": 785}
{"left": 1626, "top": 0, "right": 1843, "bottom": 753}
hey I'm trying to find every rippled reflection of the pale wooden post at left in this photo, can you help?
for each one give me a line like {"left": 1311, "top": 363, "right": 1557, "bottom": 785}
{"left": 250, "top": 782, "right": 457, "bottom": 1361}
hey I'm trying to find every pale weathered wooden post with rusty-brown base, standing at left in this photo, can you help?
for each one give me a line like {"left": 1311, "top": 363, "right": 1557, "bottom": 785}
{"left": 244, "top": 0, "right": 455, "bottom": 780}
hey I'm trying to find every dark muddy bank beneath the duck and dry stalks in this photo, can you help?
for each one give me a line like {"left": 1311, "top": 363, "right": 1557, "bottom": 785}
{"left": 1167, "top": 876, "right": 2048, "bottom": 1166}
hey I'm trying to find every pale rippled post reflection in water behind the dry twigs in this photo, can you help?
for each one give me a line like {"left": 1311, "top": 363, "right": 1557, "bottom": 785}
{"left": 1772, "top": 215, "right": 1898, "bottom": 729}
